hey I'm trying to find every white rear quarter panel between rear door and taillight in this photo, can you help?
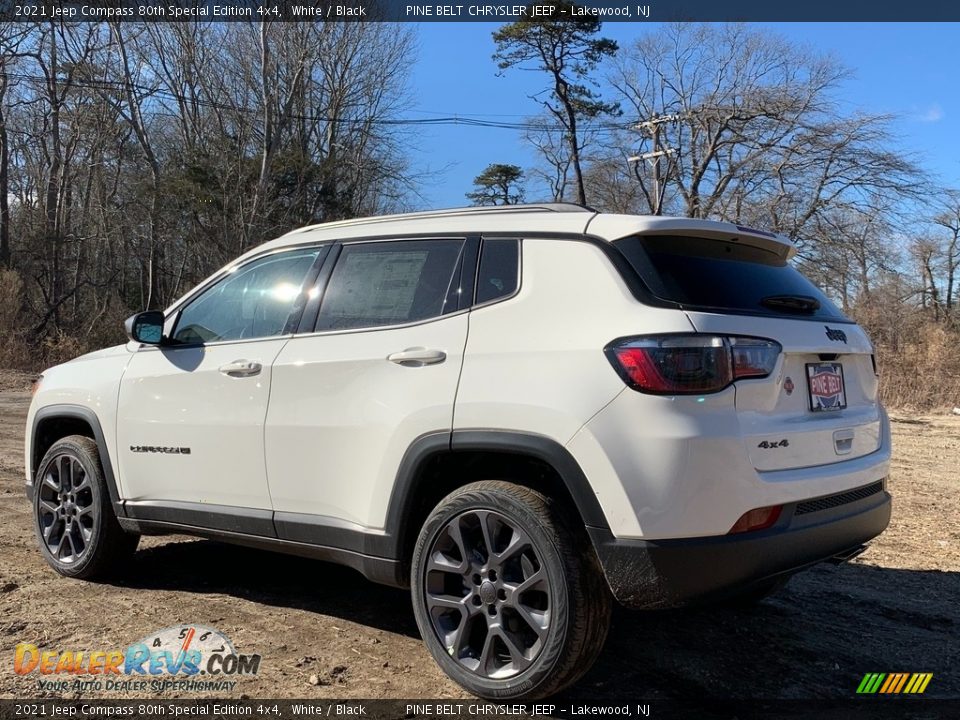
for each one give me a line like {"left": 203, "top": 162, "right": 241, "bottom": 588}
{"left": 454, "top": 239, "right": 692, "bottom": 445}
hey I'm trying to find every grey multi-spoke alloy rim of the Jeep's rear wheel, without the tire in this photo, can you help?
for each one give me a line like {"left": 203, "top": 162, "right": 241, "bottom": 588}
{"left": 424, "top": 510, "right": 553, "bottom": 680}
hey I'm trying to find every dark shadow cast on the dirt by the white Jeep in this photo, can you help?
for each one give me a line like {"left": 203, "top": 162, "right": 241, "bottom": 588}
{"left": 118, "top": 540, "right": 960, "bottom": 702}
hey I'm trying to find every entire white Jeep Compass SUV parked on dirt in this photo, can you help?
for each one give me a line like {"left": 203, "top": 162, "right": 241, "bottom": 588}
{"left": 26, "top": 204, "right": 890, "bottom": 698}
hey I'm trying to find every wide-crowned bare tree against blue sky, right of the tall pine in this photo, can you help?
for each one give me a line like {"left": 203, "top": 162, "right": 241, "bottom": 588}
{"left": 611, "top": 24, "right": 920, "bottom": 239}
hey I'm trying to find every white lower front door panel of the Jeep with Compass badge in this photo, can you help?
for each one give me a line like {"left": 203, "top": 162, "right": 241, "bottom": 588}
{"left": 114, "top": 337, "right": 287, "bottom": 509}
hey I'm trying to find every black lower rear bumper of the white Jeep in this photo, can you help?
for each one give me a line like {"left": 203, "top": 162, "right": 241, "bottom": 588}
{"left": 588, "top": 486, "right": 891, "bottom": 608}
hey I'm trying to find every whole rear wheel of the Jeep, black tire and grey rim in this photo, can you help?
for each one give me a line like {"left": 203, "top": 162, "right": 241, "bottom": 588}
{"left": 411, "top": 481, "right": 612, "bottom": 700}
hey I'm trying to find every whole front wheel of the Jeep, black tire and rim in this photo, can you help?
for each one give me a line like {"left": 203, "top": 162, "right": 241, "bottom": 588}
{"left": 33, "top": 435, "right": 140, "bottom": 580}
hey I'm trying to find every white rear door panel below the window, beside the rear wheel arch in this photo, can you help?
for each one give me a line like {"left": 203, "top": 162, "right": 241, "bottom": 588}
{"left": 266, "top": 312, "right": 467, "bottom": 529}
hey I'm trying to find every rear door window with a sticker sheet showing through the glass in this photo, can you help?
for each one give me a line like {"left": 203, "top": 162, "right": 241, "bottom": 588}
{"left": 316, "top": 240, "right": 464, "bottom": 331}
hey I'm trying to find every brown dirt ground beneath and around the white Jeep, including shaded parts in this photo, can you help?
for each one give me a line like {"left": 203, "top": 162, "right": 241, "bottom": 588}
{"left": 0, "top": 366, "right": 960, "bottom": 701}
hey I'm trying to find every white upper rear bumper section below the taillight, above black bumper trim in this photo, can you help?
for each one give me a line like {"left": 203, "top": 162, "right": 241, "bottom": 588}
{"left": 567, "top": 387, "right": 890, "bottom": 540}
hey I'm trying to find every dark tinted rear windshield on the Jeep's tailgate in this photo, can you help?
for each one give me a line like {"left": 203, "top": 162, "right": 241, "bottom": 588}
{"left": 614, "top": 235, "right": 849, "bottom": 322}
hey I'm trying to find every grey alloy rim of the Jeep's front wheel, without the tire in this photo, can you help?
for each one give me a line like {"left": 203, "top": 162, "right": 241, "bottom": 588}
{"left": 37, "top": 455, "right": 97, "bottom": 564}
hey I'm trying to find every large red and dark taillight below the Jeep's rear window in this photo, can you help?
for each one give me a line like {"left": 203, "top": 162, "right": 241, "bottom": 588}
{"left": 604, "top": 334, "right": 782, "bottom": 395}
